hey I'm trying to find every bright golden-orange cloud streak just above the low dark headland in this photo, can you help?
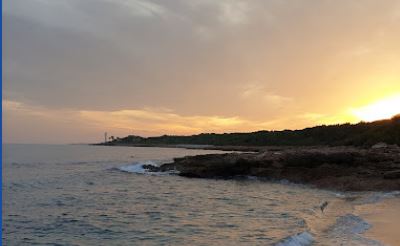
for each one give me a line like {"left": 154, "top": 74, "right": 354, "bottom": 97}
{"left": 79, "top": 104, "right": 282, "bottom": 135}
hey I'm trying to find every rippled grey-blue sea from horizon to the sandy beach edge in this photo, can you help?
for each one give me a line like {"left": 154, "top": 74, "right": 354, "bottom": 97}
{"left": 2, "top": 144, "right": 398, "bottom": 246}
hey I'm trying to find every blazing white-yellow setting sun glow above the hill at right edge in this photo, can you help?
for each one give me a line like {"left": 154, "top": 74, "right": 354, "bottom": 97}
{"left": 351, "top": 94, "right": 400, "bottom": 122}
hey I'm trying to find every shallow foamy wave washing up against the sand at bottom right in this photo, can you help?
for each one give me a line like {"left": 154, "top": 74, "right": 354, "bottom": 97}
{"left": 288, "top": 191, "right": 394, "bottom": 246}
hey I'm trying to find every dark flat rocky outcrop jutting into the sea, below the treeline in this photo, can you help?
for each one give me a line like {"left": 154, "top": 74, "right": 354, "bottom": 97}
{"left": 144, "top": 145, "right": 400, "bottom": 191}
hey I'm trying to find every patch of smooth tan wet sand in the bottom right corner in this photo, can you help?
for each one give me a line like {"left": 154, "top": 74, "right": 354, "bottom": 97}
{"left": 356, "top": 198, "right": 400, "bottom": 246}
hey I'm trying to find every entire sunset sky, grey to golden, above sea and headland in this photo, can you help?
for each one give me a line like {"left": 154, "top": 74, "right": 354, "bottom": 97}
{"left": 2, "top": 0, "right": 400, "bottom": 143}
